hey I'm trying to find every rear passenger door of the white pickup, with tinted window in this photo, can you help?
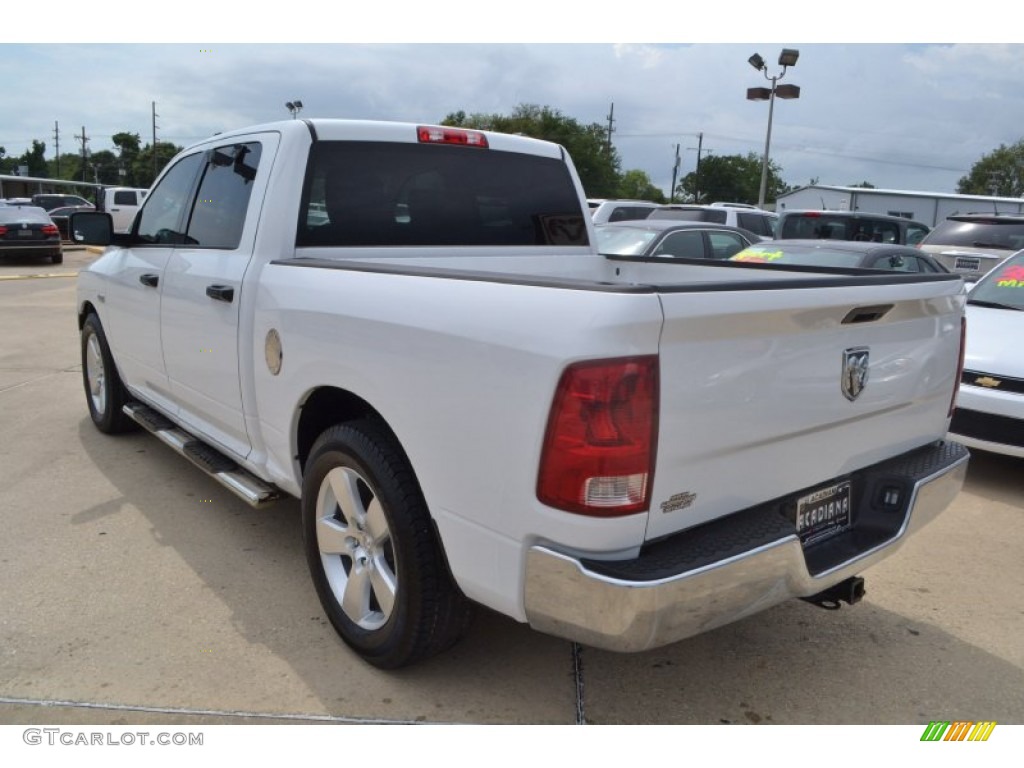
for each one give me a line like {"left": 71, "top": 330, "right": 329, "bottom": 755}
{"left": 161, "top": 135, "right": 276, "bottom": 457}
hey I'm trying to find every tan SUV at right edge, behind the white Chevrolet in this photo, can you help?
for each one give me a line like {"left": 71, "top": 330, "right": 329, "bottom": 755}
{"left": 919, "top": 213, "right": 1024, "bottom": 281}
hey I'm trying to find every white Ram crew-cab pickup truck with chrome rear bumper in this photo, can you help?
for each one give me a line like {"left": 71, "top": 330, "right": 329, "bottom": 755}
{"left": 72, "top": 120, "right": 968, "bottom": 668}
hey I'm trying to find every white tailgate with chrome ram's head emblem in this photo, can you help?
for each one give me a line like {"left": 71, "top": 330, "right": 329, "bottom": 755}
{"left": 647, "top": 275, "right": 964, "bottom": 540}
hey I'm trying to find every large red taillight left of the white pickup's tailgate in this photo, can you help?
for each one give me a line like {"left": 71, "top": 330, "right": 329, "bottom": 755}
{"left": 537, "top": 355, "right": 658, "bottom": 517}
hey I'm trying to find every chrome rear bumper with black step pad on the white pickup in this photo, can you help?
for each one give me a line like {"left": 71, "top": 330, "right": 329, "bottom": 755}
{"left": 525, "top": 442, "right": 970, "bottom": 651}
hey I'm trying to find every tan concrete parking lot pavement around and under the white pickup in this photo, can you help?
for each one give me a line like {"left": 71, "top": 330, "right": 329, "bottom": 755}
{"left": 0, "top": 276, "right": 1024, "bottom": 724}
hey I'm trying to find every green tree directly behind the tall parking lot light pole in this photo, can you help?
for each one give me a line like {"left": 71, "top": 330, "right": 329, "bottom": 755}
{"left": 676, "top": 152, "right": 790, "bottom": 204}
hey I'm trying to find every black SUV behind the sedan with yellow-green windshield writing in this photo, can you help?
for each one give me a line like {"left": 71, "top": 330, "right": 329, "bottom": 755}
{"left": 775, "top": 211, "right": 929, "bottom": 246}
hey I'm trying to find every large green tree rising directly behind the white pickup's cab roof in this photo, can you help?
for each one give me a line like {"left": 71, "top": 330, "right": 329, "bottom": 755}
{"left": 441, "top": 104, "right": 621, "bottom": 198}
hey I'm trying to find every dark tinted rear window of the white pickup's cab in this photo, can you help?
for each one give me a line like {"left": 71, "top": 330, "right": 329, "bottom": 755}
{"left": 297, "top": 141, "right": 589, "bottom": 246}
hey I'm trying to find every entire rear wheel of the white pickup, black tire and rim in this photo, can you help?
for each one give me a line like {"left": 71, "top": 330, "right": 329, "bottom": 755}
{"left": 302, "top": 420, "right": 472, "bottom": 669}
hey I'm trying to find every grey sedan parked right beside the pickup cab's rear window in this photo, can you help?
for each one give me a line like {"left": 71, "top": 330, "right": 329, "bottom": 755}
{"left": 594, "top": 219, "right": 761, "bottom": 260}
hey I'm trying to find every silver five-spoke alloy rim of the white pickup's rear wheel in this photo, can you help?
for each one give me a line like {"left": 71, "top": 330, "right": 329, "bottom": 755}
{"left": 315, "top": 467, "right": 398, "bottom": 631}
